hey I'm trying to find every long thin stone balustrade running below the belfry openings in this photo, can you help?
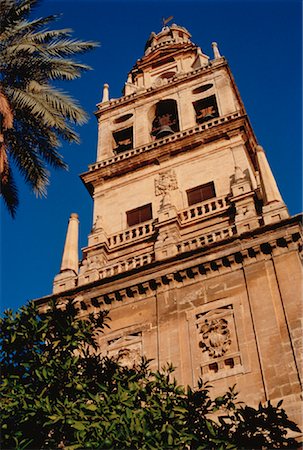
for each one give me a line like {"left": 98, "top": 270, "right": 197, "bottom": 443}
{"left": 88, "top": 111, "right": 241, "bottom": 172}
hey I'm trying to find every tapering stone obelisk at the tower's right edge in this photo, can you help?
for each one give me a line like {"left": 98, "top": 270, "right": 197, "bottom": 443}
{"left": 256, "top": 145, "right": 283, "bottom": 205}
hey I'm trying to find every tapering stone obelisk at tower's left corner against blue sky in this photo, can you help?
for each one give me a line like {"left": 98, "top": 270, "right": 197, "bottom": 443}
{"left": 60, "top": 213, "right": 79, "bottom": 274}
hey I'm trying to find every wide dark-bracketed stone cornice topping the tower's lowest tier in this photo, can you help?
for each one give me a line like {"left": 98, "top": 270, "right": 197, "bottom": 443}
{"left": 35, "top": 214, "right": 302, "bottom": 310}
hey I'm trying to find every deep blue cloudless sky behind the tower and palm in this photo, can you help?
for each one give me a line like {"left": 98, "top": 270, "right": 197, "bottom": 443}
{"left": 0, "top": 0, "right": 302, "bottom": 311}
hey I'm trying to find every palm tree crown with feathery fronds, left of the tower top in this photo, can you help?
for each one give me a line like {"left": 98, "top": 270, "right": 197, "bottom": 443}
{"left": 0, "top": 0, "right": 98, "bottom": 216}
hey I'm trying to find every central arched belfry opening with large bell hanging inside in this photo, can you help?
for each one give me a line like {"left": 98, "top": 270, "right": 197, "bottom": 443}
{"left": 151, "top": 100, "right": 180, "bottom": 139}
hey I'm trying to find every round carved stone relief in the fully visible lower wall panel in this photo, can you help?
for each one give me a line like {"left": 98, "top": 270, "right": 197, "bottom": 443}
{"left": 200, "top": 318, "right": 231, "bottom": 358}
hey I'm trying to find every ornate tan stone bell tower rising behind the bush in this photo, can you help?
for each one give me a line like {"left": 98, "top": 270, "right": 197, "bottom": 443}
{"left": 40, "top": 25, "right": 302, "bottom": 428}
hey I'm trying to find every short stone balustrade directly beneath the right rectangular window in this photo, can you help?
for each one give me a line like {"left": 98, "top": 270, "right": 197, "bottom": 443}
{"left": 178, "top": 196, "right": 229, "bottom": 224}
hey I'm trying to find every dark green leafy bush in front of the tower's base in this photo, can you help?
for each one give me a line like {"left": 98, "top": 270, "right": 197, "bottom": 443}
{"left": 0, "top": 300, "right": 299, "bottom": 450}
